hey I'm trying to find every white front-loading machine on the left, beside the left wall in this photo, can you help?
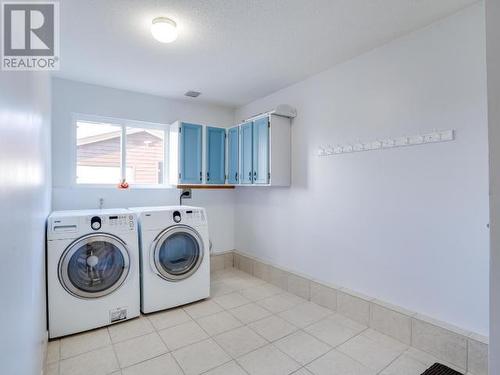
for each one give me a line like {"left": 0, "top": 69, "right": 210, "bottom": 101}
{"left": 47, "top": 209, "right": 140, "bottom": 338}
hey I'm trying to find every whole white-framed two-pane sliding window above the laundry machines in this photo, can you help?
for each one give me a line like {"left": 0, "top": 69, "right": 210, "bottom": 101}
{"left": 76, "top": 116, "right": 168, "bottom": 186}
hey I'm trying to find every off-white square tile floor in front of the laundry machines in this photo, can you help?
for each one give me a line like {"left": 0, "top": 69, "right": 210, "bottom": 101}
{"left": 46, "top": 269, "right": 464, "bottom": 375}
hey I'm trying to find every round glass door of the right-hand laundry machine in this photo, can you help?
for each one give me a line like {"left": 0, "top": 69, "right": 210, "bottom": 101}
{"left": 154, "top": 225, "right": 203, "bottom": 281}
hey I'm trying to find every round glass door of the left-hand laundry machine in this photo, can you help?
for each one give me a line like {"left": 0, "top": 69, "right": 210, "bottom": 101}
{"left": 59, "top": 234, "right": 129, "bottom": 298}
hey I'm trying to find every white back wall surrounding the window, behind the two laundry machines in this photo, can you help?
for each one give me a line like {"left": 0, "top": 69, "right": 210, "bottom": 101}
{"left": 52, "top": 78, "right": 235, "bottom": 252}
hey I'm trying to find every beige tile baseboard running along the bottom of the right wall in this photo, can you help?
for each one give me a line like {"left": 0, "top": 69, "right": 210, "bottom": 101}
{"left": 233, "top": 250, "right": 488, "bottom": 375}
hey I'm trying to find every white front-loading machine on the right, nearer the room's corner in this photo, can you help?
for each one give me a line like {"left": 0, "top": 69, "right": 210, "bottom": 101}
{"left": 130, "top": 206, "right": 210, "bottom": 313}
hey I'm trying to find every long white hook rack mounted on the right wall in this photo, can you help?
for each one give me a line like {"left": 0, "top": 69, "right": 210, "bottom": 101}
{"left": 318, "top": 130, "right": 455, "bottom": 156}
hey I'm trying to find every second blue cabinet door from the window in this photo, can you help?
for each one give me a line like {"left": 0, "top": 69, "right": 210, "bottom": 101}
{"left": 206, "top": 126, "right": 226, "bottom": 184}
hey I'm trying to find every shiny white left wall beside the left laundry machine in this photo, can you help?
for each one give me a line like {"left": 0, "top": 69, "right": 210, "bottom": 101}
{"left": 0, "top": 72, "right": 51, "bottom": 375}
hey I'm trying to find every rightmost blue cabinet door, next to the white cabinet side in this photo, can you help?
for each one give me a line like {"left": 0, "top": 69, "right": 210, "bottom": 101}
{"left": 252, "top": 117, "right": 269, "bottom": 184}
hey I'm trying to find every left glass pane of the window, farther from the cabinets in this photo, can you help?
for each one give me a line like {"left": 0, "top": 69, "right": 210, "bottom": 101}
{"left": 76, "top": 121, "right": 121, "bottom": 184}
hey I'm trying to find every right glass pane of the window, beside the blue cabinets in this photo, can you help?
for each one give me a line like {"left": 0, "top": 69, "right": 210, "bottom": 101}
{"left": 126, "top": 128, "right": 165, "bottom": 185}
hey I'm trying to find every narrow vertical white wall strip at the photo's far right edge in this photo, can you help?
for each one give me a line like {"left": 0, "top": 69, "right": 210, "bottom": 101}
{"left": 486, "top": 0, "right": 500, "bottom": 375}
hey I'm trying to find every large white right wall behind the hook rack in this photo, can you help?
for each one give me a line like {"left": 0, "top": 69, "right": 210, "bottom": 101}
{"left": 235, "top": 5, "right": 489, "bottom": 334}
